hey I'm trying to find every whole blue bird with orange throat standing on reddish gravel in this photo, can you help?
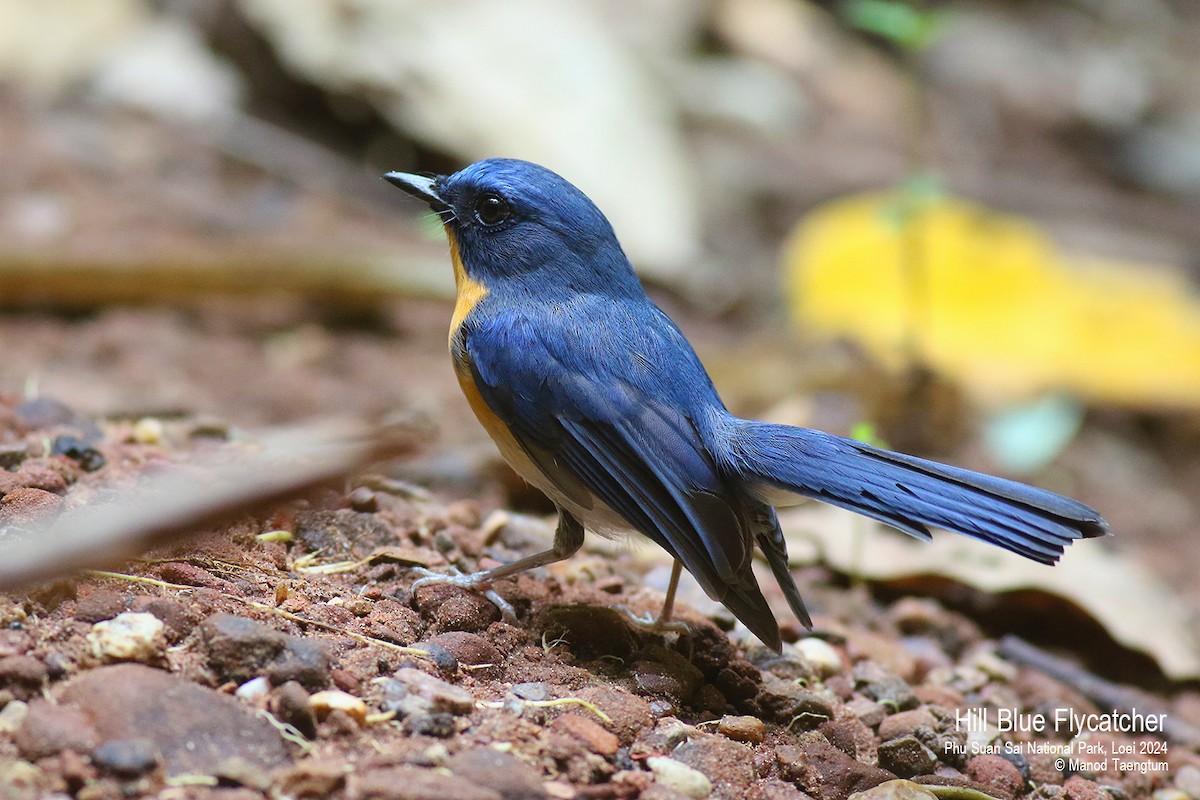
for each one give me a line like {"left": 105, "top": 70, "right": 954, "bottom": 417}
{"left": 384, "top": 158, "right": 1108, "bottom": 651}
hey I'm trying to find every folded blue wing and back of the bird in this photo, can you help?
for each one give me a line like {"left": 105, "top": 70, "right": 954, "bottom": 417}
{"left": 456, "top": 300, "right": 778, "bottom": 618}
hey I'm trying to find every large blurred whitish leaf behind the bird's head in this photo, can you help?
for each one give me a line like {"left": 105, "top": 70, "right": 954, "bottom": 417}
{"left": 239, "top": 0, "right": 700, "bottom": 276}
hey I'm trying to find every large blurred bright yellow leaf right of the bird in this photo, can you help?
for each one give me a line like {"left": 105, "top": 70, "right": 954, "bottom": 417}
{"left": 785, "top": 193, "right": 1200, "bottom": 407}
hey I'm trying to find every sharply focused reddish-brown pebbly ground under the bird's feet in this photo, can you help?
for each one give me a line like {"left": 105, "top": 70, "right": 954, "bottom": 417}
{"left": 0, "top": 376, "right": 1200, "bottom": 800}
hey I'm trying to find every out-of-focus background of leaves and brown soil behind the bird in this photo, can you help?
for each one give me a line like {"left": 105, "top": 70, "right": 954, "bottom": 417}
{"left": 0, "top": 0, "right": 1200, "bottom": 678}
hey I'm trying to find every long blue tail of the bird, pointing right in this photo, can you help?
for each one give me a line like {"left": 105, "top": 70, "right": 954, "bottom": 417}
{"left": 726, "top": 420, "right": 1108, "bottom": 564}
